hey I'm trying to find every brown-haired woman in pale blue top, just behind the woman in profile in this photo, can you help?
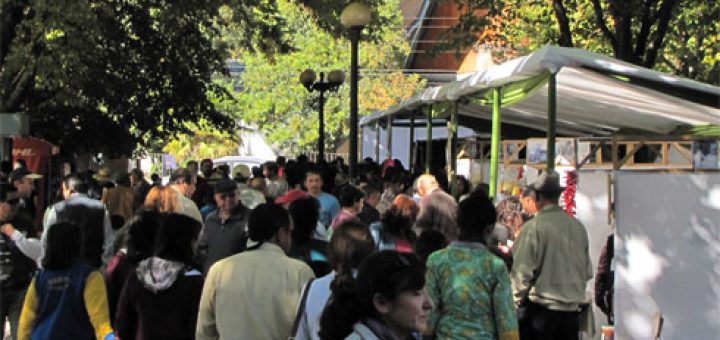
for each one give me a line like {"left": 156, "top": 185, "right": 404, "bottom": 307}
{"left": 295, "top": 221, "right": 375, "bottom": 340}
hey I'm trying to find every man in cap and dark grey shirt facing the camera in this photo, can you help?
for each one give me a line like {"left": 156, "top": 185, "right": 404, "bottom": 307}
{"left": 200, "top": 179, "right": 250, "bottom": 273}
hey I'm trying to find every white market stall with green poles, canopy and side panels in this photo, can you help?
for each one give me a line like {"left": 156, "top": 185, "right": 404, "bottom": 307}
{"left": 361, "top": 46, "right": 720, "bottom": 339}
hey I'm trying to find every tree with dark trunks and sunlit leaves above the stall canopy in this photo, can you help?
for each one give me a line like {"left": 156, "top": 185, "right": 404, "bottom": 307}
{"left": 438, "top": 0, "right": 720, "bottom": 84}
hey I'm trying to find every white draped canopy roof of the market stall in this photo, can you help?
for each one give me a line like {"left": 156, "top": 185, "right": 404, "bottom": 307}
{"left": 360, "top": 46, "right": 720, "bottom": 136}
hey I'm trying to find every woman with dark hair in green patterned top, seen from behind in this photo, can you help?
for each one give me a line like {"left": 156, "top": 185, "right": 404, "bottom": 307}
{"left": 427, "top": 191, "right": 518, "bottom": 339}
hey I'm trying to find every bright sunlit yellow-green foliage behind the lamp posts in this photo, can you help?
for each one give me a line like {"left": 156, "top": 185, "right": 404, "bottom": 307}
{"left": 228, "top": 0, "right": 422, "bottom": 154}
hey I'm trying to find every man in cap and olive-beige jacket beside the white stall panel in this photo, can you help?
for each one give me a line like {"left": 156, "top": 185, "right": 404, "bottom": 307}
{"left": 510, "top": 171, "right": 592, "bottom": 340}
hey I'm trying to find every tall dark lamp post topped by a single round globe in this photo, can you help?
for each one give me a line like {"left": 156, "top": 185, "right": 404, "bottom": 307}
{"left": 340, "top": 2, "right": 370, "bottom": 182}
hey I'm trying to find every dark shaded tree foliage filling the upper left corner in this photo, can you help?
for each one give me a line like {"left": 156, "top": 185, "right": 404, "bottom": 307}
{"left": 0, "top": 0, "right": 296, "bottom": 154}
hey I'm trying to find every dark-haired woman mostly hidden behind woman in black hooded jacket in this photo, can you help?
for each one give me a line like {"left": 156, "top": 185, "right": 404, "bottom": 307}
{"left": 105, "top": 210, "right": 162, "bottom": 320}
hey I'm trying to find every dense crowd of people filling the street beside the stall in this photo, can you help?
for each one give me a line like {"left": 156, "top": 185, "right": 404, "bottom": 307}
{"left": 0, "top": 156, "right": 612, "bottom": 340}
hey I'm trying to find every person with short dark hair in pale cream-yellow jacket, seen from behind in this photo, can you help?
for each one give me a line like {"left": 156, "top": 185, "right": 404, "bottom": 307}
{"left": 196, "top": 204, "right": 314, "bottom": 340}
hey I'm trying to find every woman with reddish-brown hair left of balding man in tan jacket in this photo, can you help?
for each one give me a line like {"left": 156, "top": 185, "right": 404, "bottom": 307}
{"left": 370, "top": 194, "right": 418, "bottom": 253}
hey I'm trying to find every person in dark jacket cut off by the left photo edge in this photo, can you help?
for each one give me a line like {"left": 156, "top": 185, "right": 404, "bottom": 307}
{"left": 0, "top": 186, "right": 37, "bottom": 339}
